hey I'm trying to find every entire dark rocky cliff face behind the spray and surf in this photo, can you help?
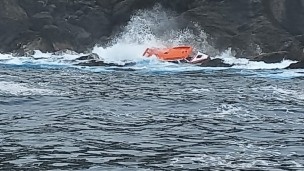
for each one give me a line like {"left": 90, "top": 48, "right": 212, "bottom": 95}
{"left": 0, "top": 0, "right": 304, "bottom": 62}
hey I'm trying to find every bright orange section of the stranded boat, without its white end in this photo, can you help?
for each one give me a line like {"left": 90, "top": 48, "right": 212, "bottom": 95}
{"left": 143, "top": 46, "right": 193, "bottom": 61}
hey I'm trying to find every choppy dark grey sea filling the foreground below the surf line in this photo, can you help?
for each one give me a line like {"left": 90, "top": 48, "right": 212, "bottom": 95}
{"left": 0, "top": 67, "right": 304, "bottom": 171}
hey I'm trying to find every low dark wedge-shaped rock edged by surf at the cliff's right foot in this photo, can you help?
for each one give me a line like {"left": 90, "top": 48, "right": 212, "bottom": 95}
{"left": 250, "top": 51, "right": 289, "bottom": 63}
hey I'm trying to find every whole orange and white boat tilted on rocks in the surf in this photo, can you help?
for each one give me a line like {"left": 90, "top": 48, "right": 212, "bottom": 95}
{"left": 143, "top": 46, "right": 210, "bottom": 64}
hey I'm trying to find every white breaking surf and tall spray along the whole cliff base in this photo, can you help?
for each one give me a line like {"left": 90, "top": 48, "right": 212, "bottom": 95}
{"left": 0, "top": 6, "right": 304, "bottom": 78}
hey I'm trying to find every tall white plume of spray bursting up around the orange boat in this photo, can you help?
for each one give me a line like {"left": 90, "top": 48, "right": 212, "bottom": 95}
{"left": 93, "top": 5, "right": 215, "bottom": 62}
